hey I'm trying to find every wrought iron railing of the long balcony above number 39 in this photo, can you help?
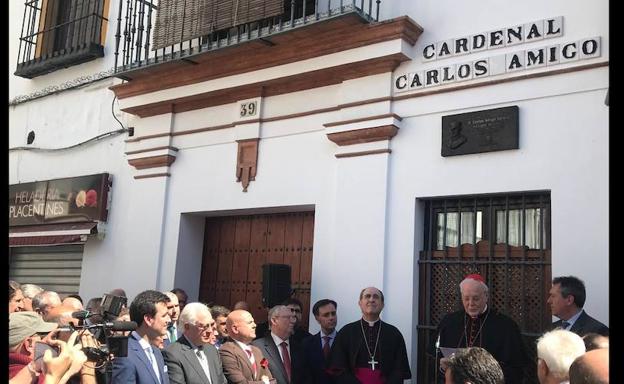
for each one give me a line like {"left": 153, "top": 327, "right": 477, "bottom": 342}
{"left": 115, "top": 0, "right": 381, "bottom": 78}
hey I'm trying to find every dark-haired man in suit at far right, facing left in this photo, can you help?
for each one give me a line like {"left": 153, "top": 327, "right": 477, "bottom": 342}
{"left": 548, "top": 276, "right": 609, "bottom": 336}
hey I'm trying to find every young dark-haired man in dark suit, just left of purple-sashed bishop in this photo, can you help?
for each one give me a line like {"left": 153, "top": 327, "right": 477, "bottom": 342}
{"left": 303, "top": 299, "right": 338, "bottom": 384}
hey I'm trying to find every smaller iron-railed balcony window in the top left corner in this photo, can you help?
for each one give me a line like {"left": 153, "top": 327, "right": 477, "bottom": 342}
{"left": 15, "top": 0, "right": 109, "bottom": 79}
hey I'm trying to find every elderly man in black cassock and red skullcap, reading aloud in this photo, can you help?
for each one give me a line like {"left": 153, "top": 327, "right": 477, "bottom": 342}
{"left": 438, "top": 275, "right": 530, "bottom": 384}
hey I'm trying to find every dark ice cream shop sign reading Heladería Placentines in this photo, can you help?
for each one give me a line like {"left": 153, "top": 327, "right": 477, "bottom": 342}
{"left": 9, "top": 173, "right": 111, "bottom": 226}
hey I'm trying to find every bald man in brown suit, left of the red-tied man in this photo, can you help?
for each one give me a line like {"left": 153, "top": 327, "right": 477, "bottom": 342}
{"left": 219, "top": 309, "right": 275, "bottom": 384}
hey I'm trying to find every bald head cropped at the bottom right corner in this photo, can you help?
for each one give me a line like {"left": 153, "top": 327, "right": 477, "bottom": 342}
{"left": 570, "top": 348, "right": 609, "bottom": 384}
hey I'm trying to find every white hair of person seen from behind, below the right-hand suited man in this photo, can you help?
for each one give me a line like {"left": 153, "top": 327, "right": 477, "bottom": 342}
{"left": 537, "top": 329, "right": 585, "bottom": 381}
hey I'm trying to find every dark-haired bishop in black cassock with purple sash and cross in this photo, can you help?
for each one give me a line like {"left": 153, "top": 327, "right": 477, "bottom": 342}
{"left": 328, "top": 287, "right": 411, "bottom": 384}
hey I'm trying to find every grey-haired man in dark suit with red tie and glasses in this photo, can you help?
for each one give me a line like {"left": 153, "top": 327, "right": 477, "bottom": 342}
{"left": 252, "top": 305, "right": 304, "bottom": 384}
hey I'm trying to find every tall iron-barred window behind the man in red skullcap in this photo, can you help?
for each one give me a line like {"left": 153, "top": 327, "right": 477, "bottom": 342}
{"left": 417, "top": 191, "right": 552, "bottom": 383}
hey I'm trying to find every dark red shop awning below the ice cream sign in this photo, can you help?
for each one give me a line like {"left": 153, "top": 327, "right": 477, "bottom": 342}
{"left": 9, "top": 221, "right": 97, "bottom": 247}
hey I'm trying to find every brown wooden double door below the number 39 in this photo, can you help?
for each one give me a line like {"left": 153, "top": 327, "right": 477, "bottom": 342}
{"left": 199, "top": 212, "right": 314, "bottom": 329}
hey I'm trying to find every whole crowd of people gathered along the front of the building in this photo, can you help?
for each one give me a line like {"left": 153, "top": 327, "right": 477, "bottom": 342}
{"left": 9, "top": 274, "right": 609, "bottom": 384}
